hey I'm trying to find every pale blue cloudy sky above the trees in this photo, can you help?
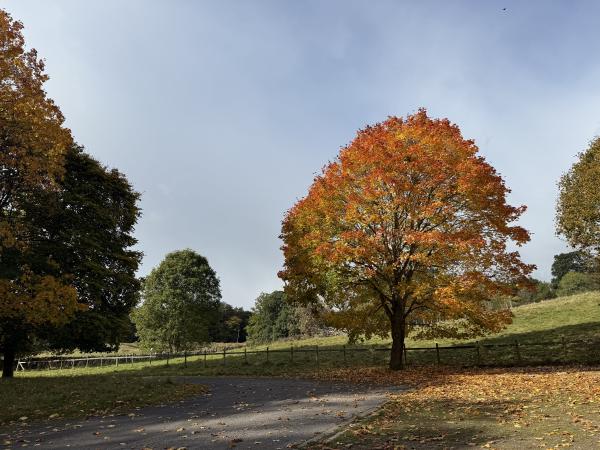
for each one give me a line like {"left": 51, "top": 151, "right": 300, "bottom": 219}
{"left": 0, "top": 0, "right": 600, "bottom": 307}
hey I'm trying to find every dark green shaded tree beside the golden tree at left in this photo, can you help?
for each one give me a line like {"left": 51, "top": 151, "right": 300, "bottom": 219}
{"left": 36, "top": 147, "right": 142, "bottom": 351}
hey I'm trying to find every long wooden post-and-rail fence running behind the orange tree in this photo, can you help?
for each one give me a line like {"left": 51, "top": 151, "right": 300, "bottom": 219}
{"left": 17, "top": 338, "right": 600, "bottom": 371}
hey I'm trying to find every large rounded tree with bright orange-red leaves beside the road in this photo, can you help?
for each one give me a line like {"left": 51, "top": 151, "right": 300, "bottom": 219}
{"left": 279, "top": 109, "right": 534, "bottom": 369}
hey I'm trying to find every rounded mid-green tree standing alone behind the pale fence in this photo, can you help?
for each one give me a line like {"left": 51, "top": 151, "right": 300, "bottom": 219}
{"left": 132, "top": 249, "right": 221, "bottom": 353}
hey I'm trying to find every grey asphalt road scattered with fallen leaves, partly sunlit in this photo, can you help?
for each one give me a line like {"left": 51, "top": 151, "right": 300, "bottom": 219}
{"left": 0, "top": 377, "right": 398, "bottom": 450}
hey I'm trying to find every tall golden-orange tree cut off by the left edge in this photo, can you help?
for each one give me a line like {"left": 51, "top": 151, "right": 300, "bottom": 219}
{"left": 0, "top": 10, "right": 81, "bottom": 377}
